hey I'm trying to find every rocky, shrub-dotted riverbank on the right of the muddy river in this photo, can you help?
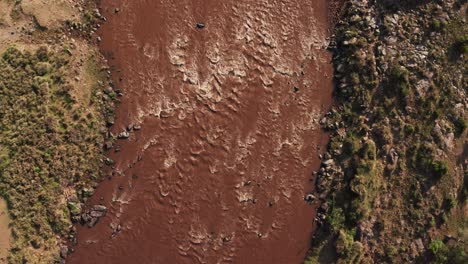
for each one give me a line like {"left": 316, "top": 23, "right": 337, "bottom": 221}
{"left": 306, "top": 1, "right": 468, "bottom": 263}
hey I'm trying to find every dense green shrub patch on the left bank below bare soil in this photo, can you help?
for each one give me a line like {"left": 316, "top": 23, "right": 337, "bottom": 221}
{"left": 0, "top": 47, "right": 103, "bottom": 263}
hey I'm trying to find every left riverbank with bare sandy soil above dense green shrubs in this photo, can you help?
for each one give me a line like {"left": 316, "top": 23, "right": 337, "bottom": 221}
{"left": 0, "top": 0, "right": 113, "bottom": 263}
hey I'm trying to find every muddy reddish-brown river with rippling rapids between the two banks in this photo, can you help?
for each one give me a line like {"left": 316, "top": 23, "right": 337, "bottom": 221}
{"left": 67, "top": 0, "right": 332, "bottom": 263}
